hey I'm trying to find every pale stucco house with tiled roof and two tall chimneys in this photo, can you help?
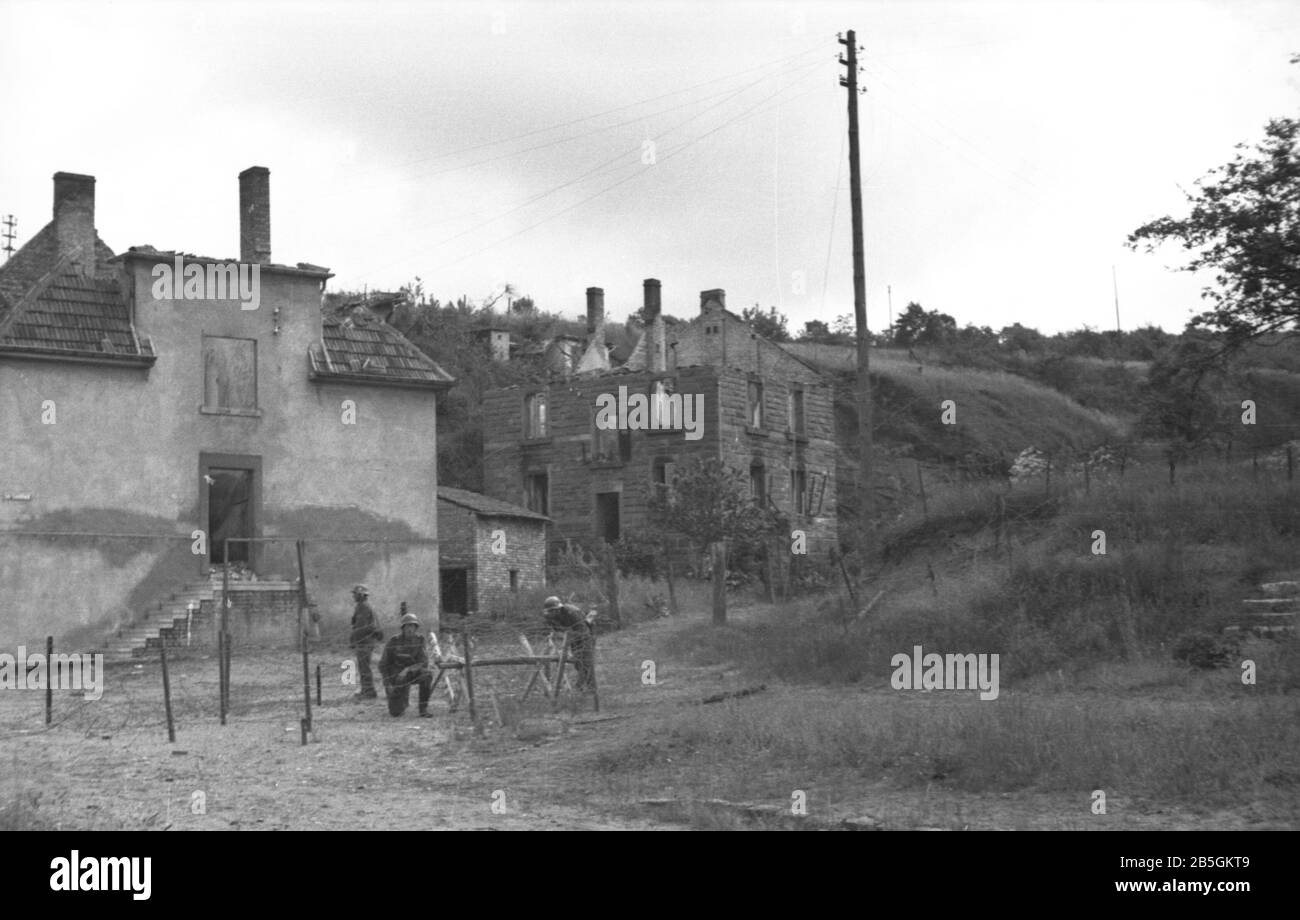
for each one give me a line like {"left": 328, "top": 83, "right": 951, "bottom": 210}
{"left": 0, "top": 166, "right": 452, "bottom": 646}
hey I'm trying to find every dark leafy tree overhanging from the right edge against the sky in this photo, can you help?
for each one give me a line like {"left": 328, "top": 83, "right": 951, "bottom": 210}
{"left": 1128, "top": 112, "right": 1300, "bottom": 348}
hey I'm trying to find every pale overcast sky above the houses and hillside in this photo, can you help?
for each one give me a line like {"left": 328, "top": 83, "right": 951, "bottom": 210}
{"left": 0, "top": 0, "right": 1300, "bottom": 331}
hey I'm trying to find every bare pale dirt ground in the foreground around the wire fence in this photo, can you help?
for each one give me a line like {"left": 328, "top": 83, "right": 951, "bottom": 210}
{"left": 0, "top": 611, "right": 1295, "bottom": 830}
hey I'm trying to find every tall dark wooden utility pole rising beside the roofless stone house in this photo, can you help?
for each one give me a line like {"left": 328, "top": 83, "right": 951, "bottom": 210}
{"left": 840, "top": 29, "right": 875, "bottom": 557}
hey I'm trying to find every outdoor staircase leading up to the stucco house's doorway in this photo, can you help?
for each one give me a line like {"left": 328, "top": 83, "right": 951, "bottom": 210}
{"left": 96, "top": 573, "right": 298, "bottom": 663}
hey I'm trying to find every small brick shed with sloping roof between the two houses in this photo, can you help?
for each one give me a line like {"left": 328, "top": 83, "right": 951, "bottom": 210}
{"left": 438, "top": 486, "right": 550, "bottom": 615}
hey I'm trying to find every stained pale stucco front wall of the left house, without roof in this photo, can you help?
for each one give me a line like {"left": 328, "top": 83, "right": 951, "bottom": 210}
{"left": 0, "top": 260, "right": 438, "bottom": 643}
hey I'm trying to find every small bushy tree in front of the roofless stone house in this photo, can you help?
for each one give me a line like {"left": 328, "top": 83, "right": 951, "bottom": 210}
{"left": 647, "top": 457, "right": 784, "bottom": 625}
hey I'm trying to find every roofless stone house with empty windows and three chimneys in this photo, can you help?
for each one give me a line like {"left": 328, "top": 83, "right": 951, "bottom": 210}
{"left": 484, "top": 278, "right": 836, "bottom": 566}
